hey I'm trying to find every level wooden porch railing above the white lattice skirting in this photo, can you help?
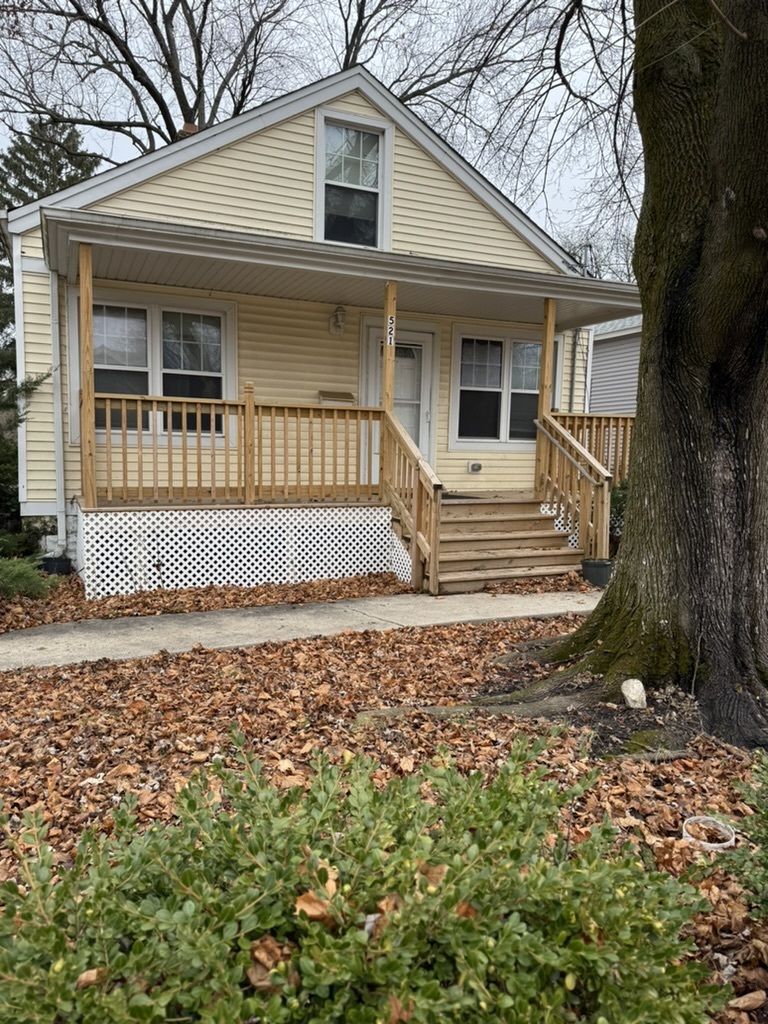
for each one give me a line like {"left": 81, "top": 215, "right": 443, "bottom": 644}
{"left": 94, "top": 387, "right": 382, "bottom": 505}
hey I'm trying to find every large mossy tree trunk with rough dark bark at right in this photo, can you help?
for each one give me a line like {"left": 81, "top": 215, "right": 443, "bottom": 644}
{"left": 577, "top": 0, "right": 768, "bottom": 745}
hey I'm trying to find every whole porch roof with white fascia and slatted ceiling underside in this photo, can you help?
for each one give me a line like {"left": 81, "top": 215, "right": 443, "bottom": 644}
{"left": 41, "top": 208, "right": 640, "bottom": 330}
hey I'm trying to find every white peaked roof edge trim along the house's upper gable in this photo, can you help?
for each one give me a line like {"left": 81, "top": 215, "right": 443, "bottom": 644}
{"left": 8, "top": 67, "right": 581, "bottom": 276}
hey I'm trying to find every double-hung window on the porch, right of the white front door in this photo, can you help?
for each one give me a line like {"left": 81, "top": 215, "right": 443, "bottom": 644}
{"left": 453, "top": 331, "right": 542, "bottom": 450}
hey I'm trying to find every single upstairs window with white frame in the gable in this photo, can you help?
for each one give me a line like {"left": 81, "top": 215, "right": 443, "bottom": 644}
{"left": 316, "top": 111, "right": 391, "bottom": 249}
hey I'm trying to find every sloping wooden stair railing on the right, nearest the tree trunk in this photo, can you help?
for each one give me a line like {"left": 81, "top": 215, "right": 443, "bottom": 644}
{"left": 536, "top": 416, "right": 611, "bottom": 558}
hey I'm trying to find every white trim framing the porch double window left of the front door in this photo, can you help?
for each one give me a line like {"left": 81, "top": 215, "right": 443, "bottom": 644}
{"left": 67, "top": 288, "right": 238, "bottom": 444}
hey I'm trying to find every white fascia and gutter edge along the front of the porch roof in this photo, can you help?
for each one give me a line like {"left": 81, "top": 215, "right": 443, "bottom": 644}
{"left": 42, "top": 208, "right": 640, "bottom": 309}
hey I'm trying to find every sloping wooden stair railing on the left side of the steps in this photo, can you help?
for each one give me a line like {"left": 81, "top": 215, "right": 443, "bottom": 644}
{"left": 381, "top": 413, "right": 442, "bottom": 594}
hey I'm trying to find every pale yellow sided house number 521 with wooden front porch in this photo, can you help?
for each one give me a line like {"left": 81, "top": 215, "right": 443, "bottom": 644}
{"left": 0, "top": 68, "right": 639, "bottom": 596}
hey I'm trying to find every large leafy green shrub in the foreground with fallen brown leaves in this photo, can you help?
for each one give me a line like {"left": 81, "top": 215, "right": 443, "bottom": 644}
{"left": 0, "top": 744, "right": 717, "bottom": 1024}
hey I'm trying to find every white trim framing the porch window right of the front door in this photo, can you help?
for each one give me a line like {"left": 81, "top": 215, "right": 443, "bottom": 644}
{"left": 449, "top": 324, "right": 563, "bottom": 453}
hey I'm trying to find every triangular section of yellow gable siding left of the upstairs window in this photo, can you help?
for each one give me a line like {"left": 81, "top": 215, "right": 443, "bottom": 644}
{"left": 92, "top": 112, "right": 314, "bottom": 241}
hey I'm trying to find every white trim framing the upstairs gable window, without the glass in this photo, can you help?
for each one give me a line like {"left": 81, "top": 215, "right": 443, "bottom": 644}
{"left": 314, "top": 106, "right": 394, "bottom": 251}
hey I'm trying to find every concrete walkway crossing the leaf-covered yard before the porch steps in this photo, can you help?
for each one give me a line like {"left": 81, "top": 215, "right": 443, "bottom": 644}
{"left": 0, "top": 591, "right": 601, "bottom": 671}
